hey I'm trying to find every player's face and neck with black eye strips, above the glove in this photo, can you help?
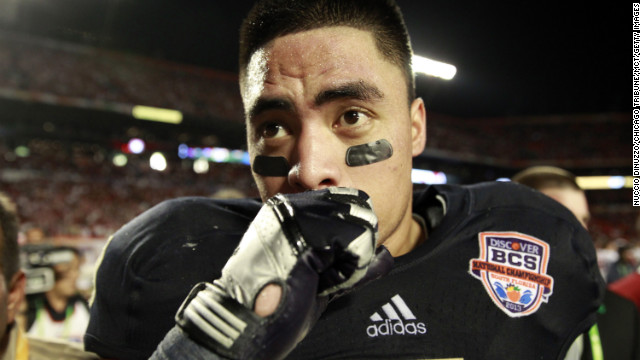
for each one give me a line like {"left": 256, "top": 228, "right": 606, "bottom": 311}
{"left": 242, "top": 27, "right": 426, "bottom": 252}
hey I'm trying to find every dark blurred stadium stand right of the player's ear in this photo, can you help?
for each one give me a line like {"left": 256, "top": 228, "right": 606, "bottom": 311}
{"left": 427, "top": 114, "right": 632, "bottom": 168}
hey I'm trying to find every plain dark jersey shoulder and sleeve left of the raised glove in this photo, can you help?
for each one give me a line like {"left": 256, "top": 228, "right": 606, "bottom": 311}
{"left": 84, "top": 197, "right": 261, "bottom": 359}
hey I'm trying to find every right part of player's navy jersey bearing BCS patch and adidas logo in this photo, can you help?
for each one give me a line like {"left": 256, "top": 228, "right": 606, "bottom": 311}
{"left": 290, "top": 183, "right": 603, "bottom": 360}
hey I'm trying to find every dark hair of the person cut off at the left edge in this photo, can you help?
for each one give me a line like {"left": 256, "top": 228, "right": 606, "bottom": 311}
{"left": 0, "top": 192, "right": 20, "bottom": 283}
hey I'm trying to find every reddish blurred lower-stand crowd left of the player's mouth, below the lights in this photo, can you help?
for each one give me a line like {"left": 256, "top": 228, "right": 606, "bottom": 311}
{"left": 0, "top": 141, "right": 257, "bottom": 238}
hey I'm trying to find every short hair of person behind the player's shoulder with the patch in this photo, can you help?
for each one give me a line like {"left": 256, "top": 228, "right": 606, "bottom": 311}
{"left": 511, "top": 166, "right": 582, "bottom": 190}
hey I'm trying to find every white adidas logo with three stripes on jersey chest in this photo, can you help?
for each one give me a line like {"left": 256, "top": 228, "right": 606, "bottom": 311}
{"left": 367, "top": 295, "right": 427, "bottom": 337}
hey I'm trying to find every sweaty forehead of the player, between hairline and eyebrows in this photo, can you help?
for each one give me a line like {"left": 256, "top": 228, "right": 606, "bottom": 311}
{"left": 242, "top": 26, "right": 406, "bottom": 110}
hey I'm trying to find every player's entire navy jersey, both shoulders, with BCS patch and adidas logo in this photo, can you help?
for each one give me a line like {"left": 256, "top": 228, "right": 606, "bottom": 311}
{"left": 85, "top": 183, "right": 604, "bottom": 359}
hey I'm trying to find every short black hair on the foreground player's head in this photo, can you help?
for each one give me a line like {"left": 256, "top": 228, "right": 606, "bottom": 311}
{"left": 239, "top": 0, "right": 416, "bottom": 102}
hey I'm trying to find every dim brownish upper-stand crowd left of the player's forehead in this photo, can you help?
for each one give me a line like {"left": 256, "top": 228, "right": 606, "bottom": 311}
{"left": 0, "top": 32, "right": 242, "bottom": 121}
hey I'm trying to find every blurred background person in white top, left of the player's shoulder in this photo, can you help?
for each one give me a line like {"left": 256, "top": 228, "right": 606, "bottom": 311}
{"left": 26, "top": 246, "right": 89, "bottom": 343}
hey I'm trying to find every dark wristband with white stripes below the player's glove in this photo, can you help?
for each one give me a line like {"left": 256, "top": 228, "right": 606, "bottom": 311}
{"left": 175, "top": 282, "right": 266, "bottom": 359}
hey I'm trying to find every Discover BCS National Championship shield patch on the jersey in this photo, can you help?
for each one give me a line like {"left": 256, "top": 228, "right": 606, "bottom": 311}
{"left": 469, "top": 232, "right": 553, "bottom": 318}
